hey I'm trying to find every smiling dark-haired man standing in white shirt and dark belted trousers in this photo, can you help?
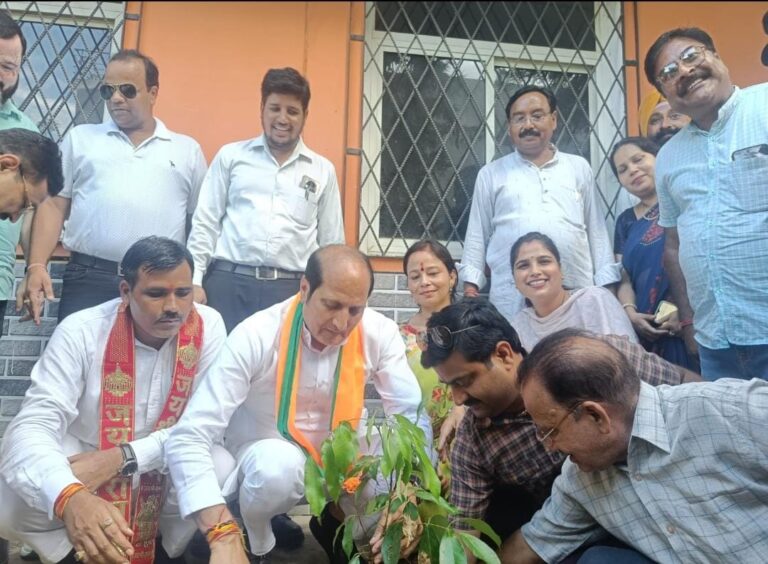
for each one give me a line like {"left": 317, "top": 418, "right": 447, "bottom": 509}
{"left": 188, "top": 68, "right": 344, "bottom": 331}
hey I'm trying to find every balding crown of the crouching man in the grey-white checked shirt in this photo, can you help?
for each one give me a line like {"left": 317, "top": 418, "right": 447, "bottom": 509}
{"left": 517, "top": 329, "right": 640, "bottom": 413}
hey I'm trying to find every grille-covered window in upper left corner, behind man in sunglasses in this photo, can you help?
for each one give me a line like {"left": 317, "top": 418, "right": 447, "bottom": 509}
{"left": 0, "top": 2, "right": 125, "bottom": 141}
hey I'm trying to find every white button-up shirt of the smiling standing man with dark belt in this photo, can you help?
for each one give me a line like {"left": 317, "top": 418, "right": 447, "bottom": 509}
{"left": 187, "top": 135, "right": 344, "bottom": 286}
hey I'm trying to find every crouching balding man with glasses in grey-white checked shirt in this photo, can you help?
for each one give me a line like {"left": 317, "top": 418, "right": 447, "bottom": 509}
{"left": 502, "top": 329, "right": 768, "bottom": 564}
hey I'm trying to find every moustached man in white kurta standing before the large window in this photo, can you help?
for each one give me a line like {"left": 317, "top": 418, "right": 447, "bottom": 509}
{"left": 461, "top": 85, "right": 621, "bottom": 320}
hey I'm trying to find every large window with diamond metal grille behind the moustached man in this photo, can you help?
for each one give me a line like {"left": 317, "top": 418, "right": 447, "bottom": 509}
{"left": 360, "top": 2, "right": 626, "bottom": 256}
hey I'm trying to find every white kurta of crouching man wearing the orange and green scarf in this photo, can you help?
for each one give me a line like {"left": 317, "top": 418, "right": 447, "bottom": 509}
{"left": 166, "top": 298, "right": 431, "bottom": 517}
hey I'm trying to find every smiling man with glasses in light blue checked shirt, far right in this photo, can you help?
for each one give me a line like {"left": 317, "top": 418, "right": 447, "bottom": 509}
{"left": 645, "top": 28, "right": 768, "bottom": 380}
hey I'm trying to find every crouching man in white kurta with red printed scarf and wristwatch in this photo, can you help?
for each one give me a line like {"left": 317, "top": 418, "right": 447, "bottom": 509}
{"left": 0, "top": 237, "right": 228, "bottom": 562}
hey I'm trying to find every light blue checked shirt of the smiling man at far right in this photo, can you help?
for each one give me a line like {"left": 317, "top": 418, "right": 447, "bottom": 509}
{"left": 656, "top": 83, "right": 768, "bottom": 349}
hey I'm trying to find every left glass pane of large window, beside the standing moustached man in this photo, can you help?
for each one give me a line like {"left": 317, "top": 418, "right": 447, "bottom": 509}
{"left": 379, "top": 53, "right": 485, "bottom": 241}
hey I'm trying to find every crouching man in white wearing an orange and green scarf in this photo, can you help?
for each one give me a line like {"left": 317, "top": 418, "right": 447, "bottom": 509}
{"left": 166, "top": 245, "right": 431, "bottom": 564}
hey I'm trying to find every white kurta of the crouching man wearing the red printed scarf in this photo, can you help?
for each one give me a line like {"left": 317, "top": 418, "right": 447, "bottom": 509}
{"left": 0, "top": 298, "right": 226, "bottom": 515}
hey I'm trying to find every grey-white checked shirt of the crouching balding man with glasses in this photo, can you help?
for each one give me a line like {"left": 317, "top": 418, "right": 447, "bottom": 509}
{"left": 522, "top": 378, "right": 768, "bottom": 564}
